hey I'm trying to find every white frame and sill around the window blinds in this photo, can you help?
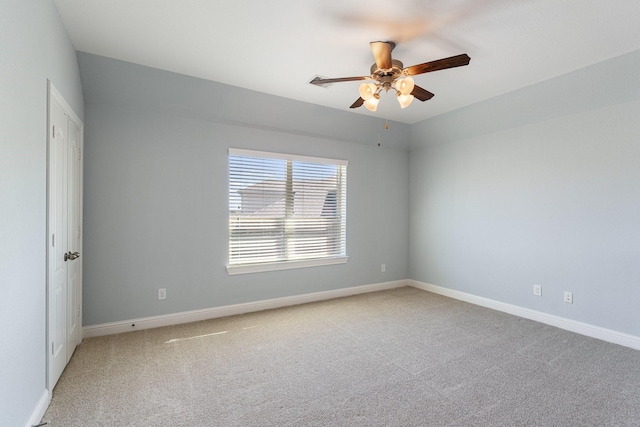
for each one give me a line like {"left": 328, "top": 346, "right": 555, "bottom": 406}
{"left": 226, "top": 148, "right": 349, "bottom": 275}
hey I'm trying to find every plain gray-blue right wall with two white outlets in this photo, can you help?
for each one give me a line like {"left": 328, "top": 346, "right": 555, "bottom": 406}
{"left": 409, "top": 51, "right": 640, "bottom": 336}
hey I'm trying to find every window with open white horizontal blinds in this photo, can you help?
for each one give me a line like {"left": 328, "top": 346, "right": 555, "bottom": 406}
{"left": 227, "top": 148, "right": 347, "bottom": 274}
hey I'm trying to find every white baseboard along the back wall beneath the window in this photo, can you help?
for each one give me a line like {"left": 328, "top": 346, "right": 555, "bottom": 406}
{"left": 82, "top": 280, "right": 408, "bottom": 338}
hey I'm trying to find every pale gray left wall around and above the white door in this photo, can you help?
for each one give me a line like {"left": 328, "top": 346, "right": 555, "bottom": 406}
{"left": 0, "top": 0, "right": 84, "bottom": 426}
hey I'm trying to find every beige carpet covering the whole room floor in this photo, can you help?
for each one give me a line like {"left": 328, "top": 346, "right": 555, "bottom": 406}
{"left": 43, "top": 288, "right": 640, "bottom": 427}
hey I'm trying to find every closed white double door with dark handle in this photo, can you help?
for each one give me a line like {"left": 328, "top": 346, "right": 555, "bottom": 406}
{"left": 47, "top": 84, "right": 82, "bottom": 390}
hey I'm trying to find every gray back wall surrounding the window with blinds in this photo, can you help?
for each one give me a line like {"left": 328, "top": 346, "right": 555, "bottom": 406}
{"left": 78, "top": 53, "right": 410, "bottom": 325}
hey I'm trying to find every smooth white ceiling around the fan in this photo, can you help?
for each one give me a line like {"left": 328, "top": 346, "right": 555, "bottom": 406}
{"left": 55, "top": 0, "right": 640, "bottom": 123}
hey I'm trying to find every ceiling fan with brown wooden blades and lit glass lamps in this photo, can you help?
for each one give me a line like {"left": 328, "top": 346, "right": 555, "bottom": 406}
{"left": 309, "top": 41, "right": 471, "bottom": 111}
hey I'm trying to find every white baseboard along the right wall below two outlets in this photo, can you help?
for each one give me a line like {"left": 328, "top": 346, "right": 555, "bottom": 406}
{"left": 408, "top": 280, "right": 640, "bottom": 350}
